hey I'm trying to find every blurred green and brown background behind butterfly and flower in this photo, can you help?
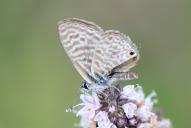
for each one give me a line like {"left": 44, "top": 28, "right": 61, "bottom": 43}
{"left": 0, "top": 0, "right": 191, "bottom": 128}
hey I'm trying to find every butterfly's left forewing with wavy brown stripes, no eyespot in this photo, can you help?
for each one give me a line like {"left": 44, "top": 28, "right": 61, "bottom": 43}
{"left": 58, "top": 18, "right": 103, "bottom": 83}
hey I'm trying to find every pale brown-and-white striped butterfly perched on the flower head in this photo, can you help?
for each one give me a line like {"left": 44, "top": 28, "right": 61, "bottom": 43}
{"left": 58, "top": 18, "right": 139, "bottom": 88}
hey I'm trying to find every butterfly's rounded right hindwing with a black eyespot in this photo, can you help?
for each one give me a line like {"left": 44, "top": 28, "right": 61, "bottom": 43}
{"left": 91, "top": 30, "right": 139, "bottom": 79}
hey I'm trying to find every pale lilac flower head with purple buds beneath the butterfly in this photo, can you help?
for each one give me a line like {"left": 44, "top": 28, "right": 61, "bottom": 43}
{"left": 68, "top": 85, "right": 172, "bottom": 128}
